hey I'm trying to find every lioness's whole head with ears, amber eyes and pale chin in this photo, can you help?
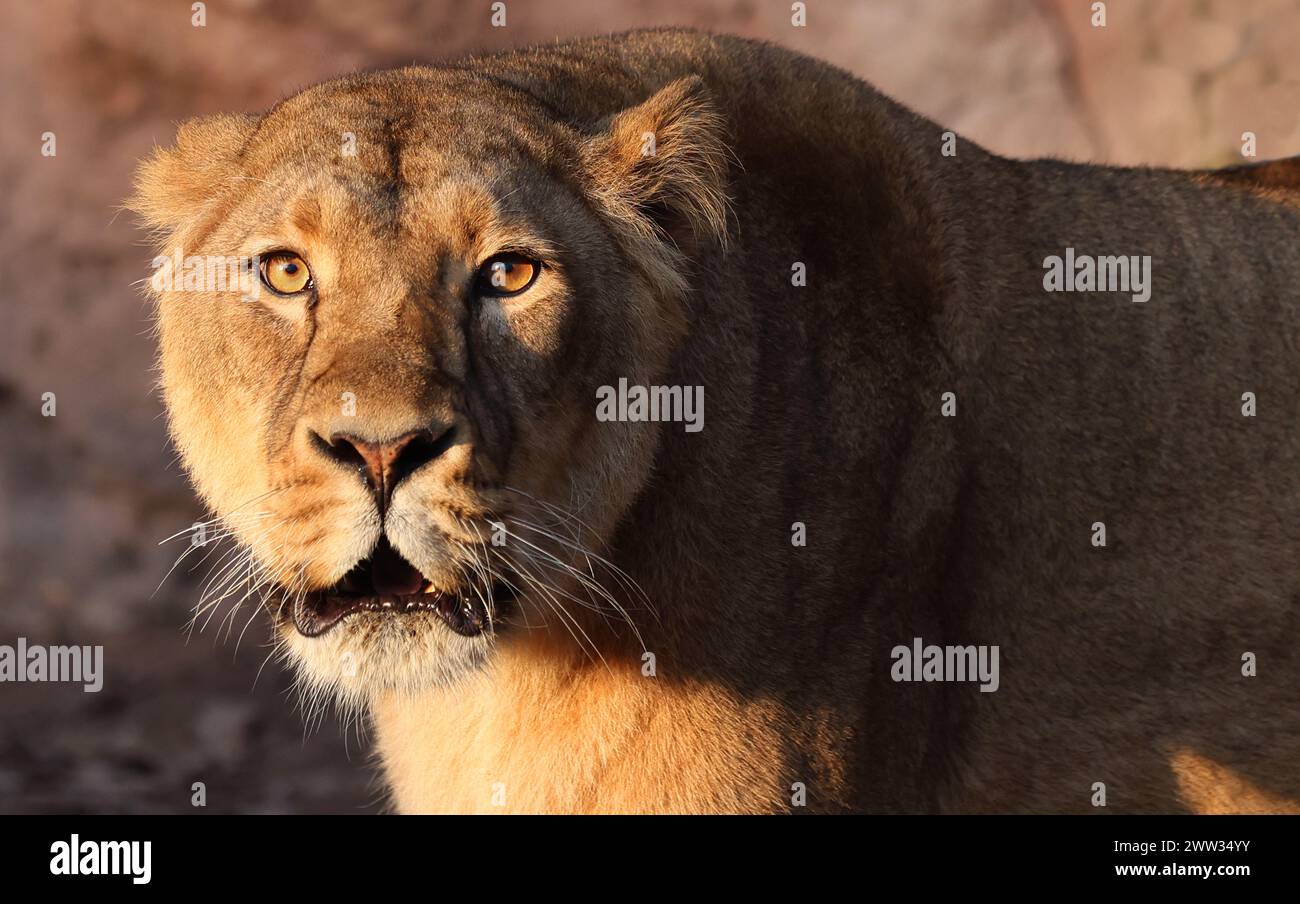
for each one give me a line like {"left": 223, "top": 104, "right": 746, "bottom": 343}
{"left": 133, "top": 69, "right": 723, "bottom": 693}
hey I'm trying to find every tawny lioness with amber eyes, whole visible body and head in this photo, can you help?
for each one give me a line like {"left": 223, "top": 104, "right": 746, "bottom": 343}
{"left": 133, "top": 30, "right": 1300, "bottom": 813}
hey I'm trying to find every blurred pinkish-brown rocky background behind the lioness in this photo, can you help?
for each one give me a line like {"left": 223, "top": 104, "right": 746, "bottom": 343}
{"left": 0, "top": 0, "right": 1300, "bottom": 813}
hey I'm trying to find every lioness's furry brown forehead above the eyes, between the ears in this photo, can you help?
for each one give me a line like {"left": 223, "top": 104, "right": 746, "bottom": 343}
{"left": 217, "top": 70, "right": 576, "bottom": 261}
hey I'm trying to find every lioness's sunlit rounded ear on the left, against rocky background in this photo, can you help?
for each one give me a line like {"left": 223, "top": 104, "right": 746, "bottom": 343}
{"left": 126, "top": 114, "right": 257, "bottom": 235}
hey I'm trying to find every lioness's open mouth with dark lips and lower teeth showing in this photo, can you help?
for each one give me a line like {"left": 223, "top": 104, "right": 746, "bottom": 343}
{"left": 291, "top": 537, "right": 514, "bottom": 637}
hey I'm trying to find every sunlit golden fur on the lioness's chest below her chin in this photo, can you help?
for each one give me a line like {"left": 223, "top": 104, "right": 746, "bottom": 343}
{"left": 373, "top": 632, "right": 790, "bottom": 813}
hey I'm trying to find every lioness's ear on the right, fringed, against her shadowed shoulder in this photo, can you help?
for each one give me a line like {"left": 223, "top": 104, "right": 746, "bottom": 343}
{"left": 584, "top": 75, "right": 728, "bottom": 247}
